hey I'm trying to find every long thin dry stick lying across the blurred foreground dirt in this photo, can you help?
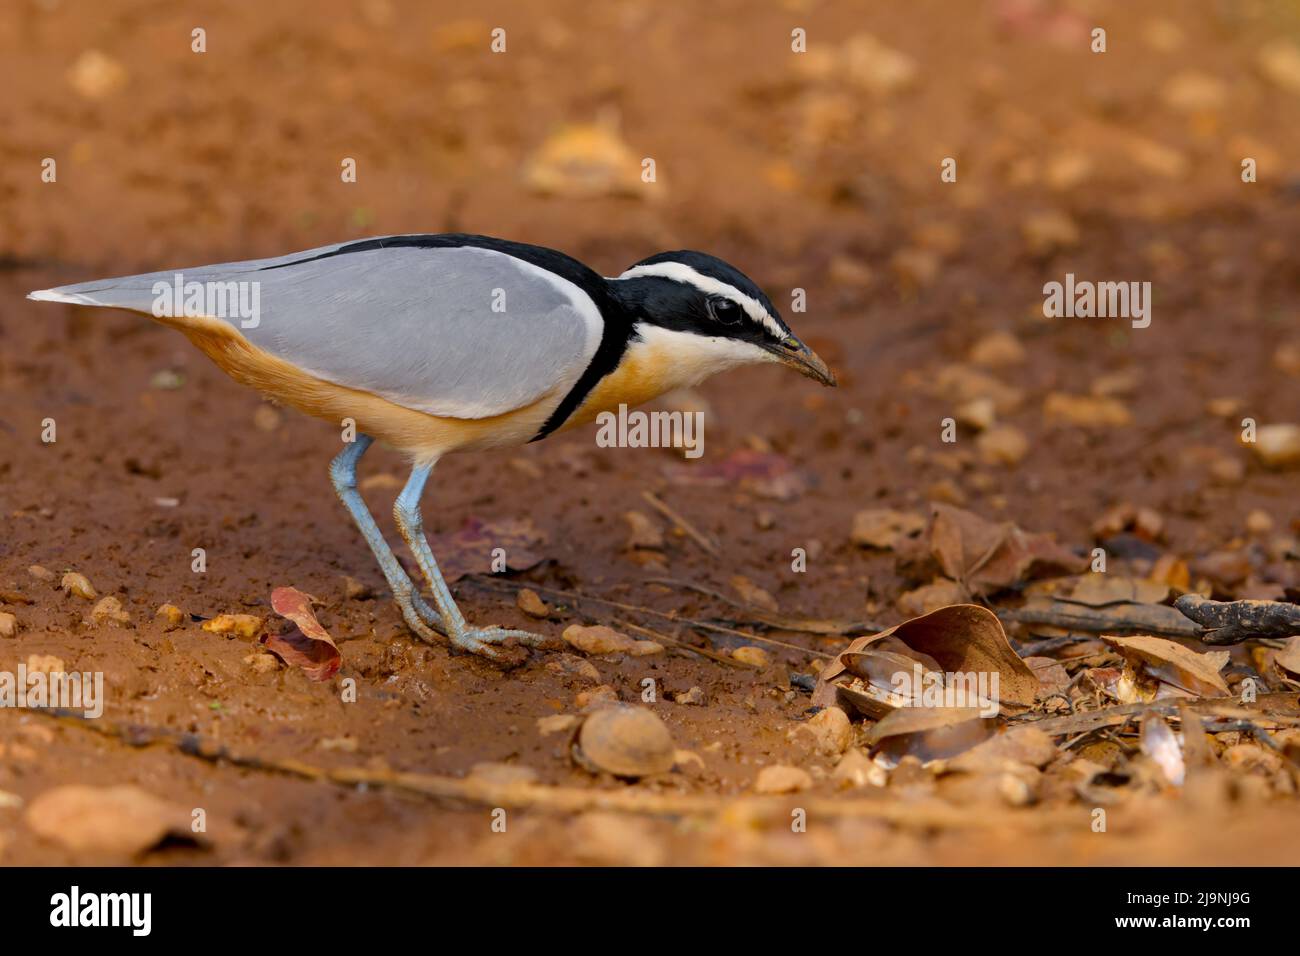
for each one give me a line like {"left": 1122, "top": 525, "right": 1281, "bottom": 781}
{"left": 35, "top": 709, "right": 1087, "bottom": 830}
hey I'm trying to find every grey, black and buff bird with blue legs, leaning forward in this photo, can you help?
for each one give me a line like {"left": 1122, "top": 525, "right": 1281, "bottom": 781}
{"left": 27, "top": 234, "right": 835, "bottom": 659}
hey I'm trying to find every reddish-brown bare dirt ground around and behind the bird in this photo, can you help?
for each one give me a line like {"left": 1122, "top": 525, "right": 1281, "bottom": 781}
{"left": 0, "top": 0, "right": 1300, "bottom": 864}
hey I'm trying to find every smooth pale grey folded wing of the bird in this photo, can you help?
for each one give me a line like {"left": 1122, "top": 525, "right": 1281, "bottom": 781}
{"left": 33, "top": 246, "right": 603, "bottom": 418}
